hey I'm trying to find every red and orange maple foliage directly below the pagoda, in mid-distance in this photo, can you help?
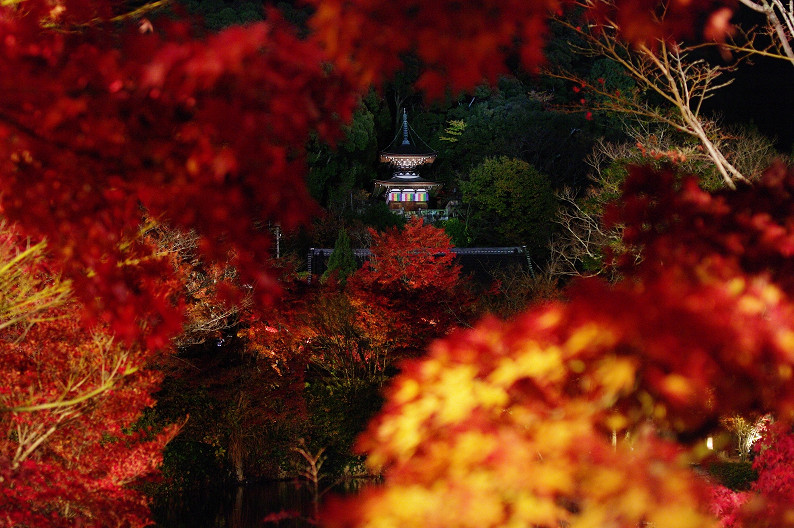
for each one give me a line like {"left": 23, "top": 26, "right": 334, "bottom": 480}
{"left": 244, "top": 218, "right": 472, "bottom": 380}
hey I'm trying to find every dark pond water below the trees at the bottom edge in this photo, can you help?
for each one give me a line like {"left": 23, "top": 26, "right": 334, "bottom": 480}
{"left": 152, "top": 481, "right": 314, "bottom": 528}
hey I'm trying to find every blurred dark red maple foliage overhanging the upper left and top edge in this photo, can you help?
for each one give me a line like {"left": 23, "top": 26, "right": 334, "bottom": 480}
{"left": 0, "top": 0, "right": 732, "bottom": 345}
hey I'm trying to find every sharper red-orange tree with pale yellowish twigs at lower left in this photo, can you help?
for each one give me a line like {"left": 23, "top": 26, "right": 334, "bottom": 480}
{"left": 0, "top": 226, "right": 175, "bottom": 527}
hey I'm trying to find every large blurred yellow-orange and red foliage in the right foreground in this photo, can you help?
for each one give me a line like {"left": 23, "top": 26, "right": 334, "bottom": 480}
{"left": 327, "top": 167, "right": 794, "bottom": 528}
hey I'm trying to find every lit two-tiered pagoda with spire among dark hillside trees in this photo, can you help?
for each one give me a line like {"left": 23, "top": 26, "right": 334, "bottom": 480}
{"left": 375, "top": 109, "right": 441, "bottom": 214}
